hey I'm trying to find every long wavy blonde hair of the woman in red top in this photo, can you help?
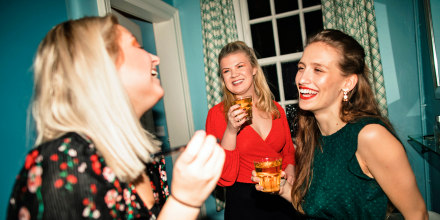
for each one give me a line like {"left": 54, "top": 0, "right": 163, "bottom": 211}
{"left": 218, "top": 41, "right": 280, "bottom": 120}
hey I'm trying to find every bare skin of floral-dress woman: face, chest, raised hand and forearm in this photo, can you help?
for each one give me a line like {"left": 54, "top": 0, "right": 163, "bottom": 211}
{"left": 115, "top": 25, "right": 225, "bottom": 219}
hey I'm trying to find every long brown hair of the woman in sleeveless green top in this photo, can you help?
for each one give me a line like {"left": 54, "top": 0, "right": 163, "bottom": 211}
{"left": 291, "top": 29, "right": 393, "bottom": 213}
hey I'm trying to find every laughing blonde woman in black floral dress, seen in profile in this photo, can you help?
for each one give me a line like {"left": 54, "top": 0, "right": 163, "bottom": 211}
{"left": 8, "top": 15, "right": 224, "bottom": 219}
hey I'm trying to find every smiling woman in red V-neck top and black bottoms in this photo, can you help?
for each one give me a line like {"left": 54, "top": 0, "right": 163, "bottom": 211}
{"left": 206, "top": 41, "right": 295, "bottom": 220}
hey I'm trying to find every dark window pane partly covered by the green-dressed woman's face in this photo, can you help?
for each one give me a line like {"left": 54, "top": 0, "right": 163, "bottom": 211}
{"left": 281, "top": 61, "right": 298, "bottom": 100}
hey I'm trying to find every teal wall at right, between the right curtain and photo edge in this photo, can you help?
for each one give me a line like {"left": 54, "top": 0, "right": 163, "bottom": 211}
{"left": 374, "top": 0, "right": 440, "bottom": 211}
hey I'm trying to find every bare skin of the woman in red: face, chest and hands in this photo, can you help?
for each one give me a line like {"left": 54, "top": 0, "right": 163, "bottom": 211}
{"left": 220, "top": 52, "right": 295, "bottom": 183}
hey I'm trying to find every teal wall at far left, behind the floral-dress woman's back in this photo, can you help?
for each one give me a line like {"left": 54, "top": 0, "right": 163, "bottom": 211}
{"left": 0, "top": 0, "right": 67, "bottom": 219}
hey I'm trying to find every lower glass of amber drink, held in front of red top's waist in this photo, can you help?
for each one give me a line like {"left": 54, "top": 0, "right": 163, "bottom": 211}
{"left": 254, "top": 157, "right": 283, "bottom": 193}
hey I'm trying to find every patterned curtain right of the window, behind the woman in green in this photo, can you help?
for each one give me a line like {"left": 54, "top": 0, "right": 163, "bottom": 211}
{"left": 321, "top": 0, "right": 388, "bottom": 116}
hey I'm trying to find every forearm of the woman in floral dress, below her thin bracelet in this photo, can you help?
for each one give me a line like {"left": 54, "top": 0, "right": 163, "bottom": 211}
{"left": 157, "top": 196, "right": 200, "bottom": 220}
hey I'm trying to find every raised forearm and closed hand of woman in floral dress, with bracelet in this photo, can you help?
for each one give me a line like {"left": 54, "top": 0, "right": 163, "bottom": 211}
{"left": 158, "top": 131, "right": 225, "bottom": 220}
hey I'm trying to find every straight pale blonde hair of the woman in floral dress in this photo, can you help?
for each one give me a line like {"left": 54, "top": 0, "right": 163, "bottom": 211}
{"left": 32, "top": 15, "right": 159, "bottom": 182}
